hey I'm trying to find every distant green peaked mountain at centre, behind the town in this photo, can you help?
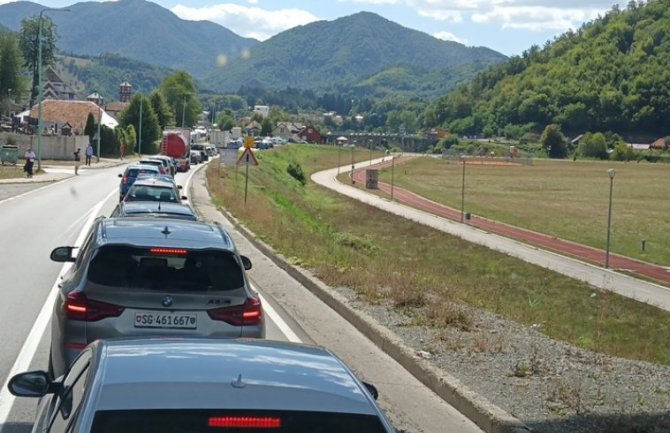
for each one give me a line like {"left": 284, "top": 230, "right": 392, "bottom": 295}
{"left": 206, "top": 12, "right": 505, "bottom": 91}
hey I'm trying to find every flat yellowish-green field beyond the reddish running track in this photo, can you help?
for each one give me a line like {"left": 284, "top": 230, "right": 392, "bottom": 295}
{"left": 380, "top": 158, "right": 670, "bottom": 266}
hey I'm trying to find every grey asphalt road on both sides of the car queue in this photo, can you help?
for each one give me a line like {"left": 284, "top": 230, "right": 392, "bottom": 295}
{"left": 0, "top": 161, "right": 481, "bottom": 433}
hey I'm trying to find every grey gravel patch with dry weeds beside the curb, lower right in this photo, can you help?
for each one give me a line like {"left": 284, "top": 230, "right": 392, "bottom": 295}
{"left": 336, "top": 288, "right": 670, "bottom": 433}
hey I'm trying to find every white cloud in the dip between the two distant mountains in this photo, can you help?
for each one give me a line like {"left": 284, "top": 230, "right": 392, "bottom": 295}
{"left": 172, "top": 0, "right": 319, "bottom": 41}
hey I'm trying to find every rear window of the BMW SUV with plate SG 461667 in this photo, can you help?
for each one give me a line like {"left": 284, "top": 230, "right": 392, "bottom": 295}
{"left": 88, "top": 246, "right": 244, "bottom": 292}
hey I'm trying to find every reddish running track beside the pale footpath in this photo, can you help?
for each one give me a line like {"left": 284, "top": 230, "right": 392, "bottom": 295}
{"left": 353, "top": 158, "right": 670, "bottom": 286}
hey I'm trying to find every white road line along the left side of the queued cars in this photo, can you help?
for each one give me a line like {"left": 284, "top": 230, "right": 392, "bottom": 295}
{"left": 0, "top": 189, "right": 117, "bottom": 433}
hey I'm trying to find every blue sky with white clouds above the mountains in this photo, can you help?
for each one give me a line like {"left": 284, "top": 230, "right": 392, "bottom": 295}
{"left": 0, "top": 0, "right": 628, "bottom": 56}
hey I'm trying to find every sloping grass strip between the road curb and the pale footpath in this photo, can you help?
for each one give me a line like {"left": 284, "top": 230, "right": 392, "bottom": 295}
{"left": 207, "top": 145, "right": 670, "bottom": 365}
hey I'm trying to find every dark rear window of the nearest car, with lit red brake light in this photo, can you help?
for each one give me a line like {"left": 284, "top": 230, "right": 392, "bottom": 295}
{"left": 91, "top": 410, "right": 387, "bottom": 433}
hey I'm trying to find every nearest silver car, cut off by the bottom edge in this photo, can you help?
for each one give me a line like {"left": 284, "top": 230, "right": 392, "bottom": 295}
{"left": 9, "top": 339, "right": 393, "bottom": 433}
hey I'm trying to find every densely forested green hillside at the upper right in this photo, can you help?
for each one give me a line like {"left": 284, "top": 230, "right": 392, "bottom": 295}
{"left": 425, "top": 0, "right": 670, "bottom": 136}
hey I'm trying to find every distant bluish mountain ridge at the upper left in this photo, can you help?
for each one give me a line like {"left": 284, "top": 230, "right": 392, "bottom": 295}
{"left": 0, "top": 0, "right": 258, "bottom": 77}
